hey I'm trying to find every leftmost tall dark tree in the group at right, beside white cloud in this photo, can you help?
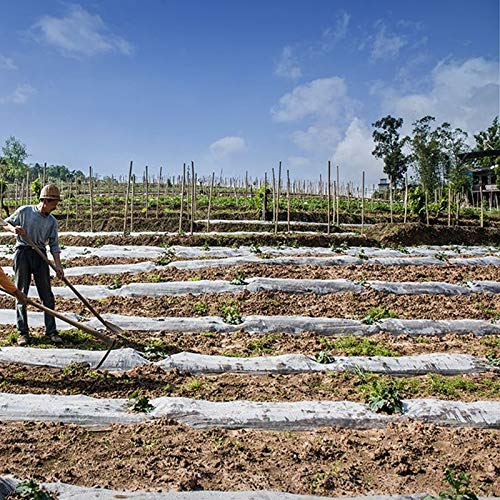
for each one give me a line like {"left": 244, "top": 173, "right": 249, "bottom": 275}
{"left": 372, "top": 115, "right": 408, "bottom": 188}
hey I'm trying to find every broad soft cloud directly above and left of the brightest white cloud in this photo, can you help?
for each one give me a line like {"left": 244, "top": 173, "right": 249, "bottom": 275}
{"left": 271, "top": 76, "right": 355, "bottom": 122}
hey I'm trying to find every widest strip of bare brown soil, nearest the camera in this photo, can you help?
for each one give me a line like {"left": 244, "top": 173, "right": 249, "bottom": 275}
{"left": 0, "top": 419, "right": 500, "bottom": 496}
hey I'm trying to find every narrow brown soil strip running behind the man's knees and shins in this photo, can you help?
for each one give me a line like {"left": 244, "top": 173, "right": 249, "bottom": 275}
{"left": 0, "top": 291, "right": 494, "bottom": 321}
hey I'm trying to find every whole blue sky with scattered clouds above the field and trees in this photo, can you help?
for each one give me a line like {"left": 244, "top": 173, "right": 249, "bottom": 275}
{"left": 0, "top": 0, "right": 499, "bottom": 183}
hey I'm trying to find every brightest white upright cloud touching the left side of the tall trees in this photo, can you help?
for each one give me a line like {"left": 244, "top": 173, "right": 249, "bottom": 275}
{"left": 332, "top": 118, "right": 384, "bottom": 186}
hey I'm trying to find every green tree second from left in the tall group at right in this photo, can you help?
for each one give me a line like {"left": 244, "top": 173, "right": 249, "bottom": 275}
{"left": 407, "top": 116, "right": 442, "bottom": 193}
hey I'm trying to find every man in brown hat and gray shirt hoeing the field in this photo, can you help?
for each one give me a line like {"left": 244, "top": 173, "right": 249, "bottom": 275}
{"left": 5, "top": 184, "right": 64, "bottom": 345}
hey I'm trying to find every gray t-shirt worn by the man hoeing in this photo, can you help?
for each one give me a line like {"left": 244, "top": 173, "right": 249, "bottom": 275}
{"left": 5, "top": 205, "right": 61, "bottom": 254}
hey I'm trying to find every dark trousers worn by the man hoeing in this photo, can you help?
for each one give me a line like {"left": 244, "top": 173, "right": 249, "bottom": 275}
{"left": 14, "top": 247, "right": 57, "bottom": 335}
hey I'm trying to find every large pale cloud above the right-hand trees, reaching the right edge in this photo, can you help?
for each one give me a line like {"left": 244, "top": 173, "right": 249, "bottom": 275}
{"left": 373, "top": 57, "right": 499, "bottom": 133}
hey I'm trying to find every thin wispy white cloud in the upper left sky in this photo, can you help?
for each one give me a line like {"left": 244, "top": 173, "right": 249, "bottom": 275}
{"left": 32, "top": 5, "right": 134, "bottom": 56}
